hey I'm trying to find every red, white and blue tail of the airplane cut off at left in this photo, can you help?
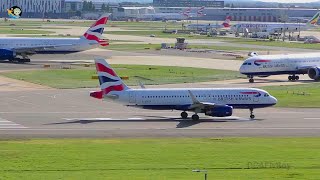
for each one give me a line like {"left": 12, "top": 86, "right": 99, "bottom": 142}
{"left": 81, "top": 14, "right": 110, "bottom": 46}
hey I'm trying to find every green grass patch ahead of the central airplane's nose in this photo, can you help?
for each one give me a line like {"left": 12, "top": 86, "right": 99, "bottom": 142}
{"left": 263, "top": 83, "right": 320, "bottom": 108}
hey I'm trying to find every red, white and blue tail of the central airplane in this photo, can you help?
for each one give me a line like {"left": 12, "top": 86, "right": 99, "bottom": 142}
{"left": 90, "top": 58, "right": 129, "bottom": 99}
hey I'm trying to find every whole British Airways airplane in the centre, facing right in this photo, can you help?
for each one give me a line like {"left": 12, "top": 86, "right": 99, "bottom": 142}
{"left": 90, "top": 59, "right": 277, "bottom": 120}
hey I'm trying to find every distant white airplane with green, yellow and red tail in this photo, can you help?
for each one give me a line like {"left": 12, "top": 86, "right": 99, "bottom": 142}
{"left": 231, "top": 12, "right": 320, "bottom": 34}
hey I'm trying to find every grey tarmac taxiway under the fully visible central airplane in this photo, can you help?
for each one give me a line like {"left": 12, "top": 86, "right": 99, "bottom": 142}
{"left": 0, "top": 83, "right": 320, "bottom": 139}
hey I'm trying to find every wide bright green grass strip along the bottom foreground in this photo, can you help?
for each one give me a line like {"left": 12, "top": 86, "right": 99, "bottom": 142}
{"left": 0, "top": 138, "right": 320, "bottom": 180}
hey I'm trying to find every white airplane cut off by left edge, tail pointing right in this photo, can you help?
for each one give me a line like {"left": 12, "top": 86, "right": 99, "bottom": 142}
{"left": 0, "top": 14, "right": 109, "bottom": 62}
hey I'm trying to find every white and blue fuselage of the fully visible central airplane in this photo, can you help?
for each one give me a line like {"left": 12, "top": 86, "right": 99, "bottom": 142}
{"left": 111, "top": 88, "right": 276, "bottom": 111}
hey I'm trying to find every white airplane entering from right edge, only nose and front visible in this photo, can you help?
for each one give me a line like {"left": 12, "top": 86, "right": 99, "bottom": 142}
{"left": 240, "top": 53, "right": 320, "bottom": 83}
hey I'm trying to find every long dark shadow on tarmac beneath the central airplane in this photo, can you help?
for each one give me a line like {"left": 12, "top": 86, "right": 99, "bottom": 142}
{"left": 44, "top": 116, "right": 255, "bottom": 128}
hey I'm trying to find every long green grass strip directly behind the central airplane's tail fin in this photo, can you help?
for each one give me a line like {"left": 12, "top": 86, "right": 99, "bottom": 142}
{"left": 1, "top": 65, "right": 243, "bottom": 88}
